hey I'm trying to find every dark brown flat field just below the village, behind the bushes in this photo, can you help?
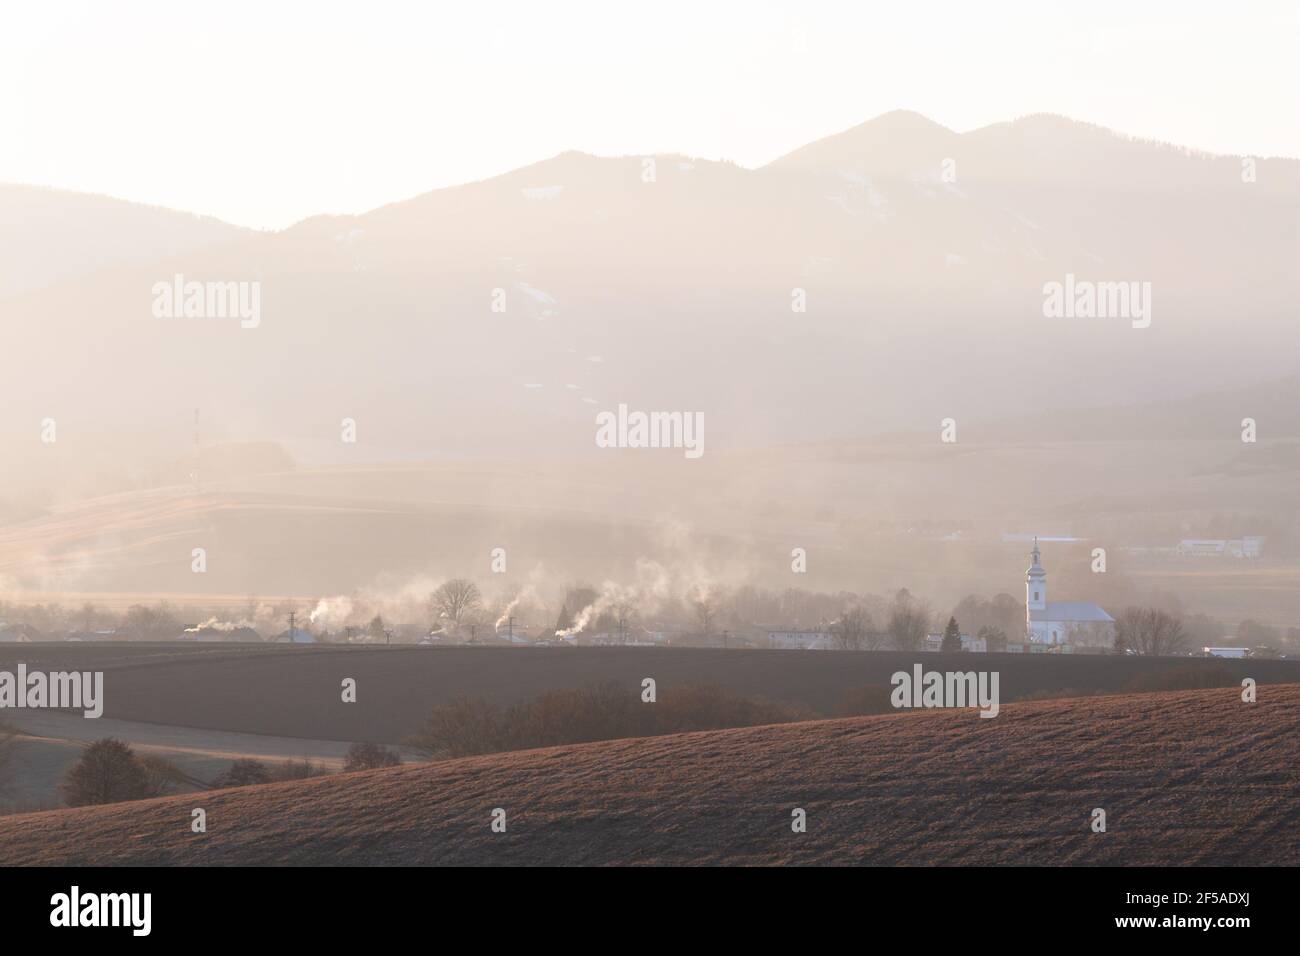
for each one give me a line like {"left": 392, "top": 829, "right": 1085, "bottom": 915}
{"left": 0, "top": 644, "right": 1300, "bottom": 743}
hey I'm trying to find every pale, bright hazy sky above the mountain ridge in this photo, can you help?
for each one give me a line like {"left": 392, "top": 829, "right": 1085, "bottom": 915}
{"left": 0, "top": 0, "right": 1300, "bottom": 228}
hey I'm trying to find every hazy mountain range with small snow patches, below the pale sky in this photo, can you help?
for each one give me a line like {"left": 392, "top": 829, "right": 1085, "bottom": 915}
{"left": 0, "top": 112, "right": 1300, "bottom": 489}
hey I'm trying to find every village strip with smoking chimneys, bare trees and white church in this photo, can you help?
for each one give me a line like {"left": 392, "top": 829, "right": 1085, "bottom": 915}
{"left": 0, "top": 537, "right": 1294, "bottom": 658}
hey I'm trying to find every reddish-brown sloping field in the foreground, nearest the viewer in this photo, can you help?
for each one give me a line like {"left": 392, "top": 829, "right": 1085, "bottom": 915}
{"left": 0, "top": 684, "right": 1300, "bottom": 866}
